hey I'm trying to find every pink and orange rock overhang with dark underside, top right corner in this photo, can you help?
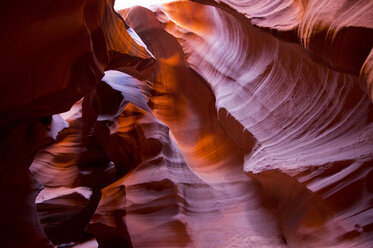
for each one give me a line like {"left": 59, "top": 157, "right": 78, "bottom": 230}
{"left": 196, "top": 0, "right": 373, "bottom": 101}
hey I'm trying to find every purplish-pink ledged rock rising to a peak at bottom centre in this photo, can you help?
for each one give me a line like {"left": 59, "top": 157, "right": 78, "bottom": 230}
{"left": 88, "top": 105, "right": 284, "bottom": 247}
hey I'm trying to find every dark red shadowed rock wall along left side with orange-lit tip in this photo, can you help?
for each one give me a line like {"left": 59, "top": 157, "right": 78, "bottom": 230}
{"left": 0, "top": 0, "right": 154, "bottom": 248}
